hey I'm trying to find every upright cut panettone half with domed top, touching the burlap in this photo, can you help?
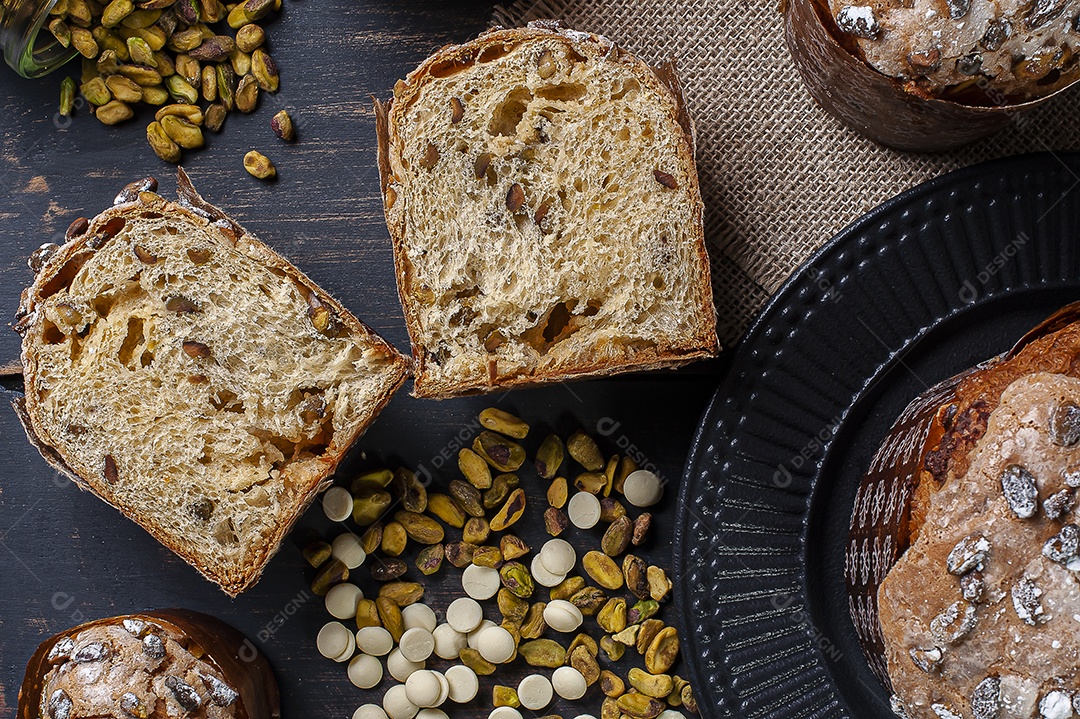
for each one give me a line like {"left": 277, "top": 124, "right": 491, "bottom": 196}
{"left": 386, "top": 28, "right": 716, "bottom": 396}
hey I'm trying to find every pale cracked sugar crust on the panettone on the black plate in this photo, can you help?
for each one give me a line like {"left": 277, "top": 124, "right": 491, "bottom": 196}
{"left": 878, "top": 372, "right": 1080, "bottom": 718}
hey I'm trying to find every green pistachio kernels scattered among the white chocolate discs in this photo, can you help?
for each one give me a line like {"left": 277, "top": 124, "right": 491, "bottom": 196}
{"left": 305, "top": 408, "right": 697, "bottom": 719}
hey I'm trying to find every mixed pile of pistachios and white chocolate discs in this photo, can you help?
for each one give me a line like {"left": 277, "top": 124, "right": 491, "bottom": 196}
{"left": 305, "top": 408, "right": 697, "bottom": 719}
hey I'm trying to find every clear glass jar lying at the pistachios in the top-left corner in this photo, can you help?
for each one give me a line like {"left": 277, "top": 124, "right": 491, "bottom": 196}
{"left": 0, "top": 0, "right": 78, "bottom": 78}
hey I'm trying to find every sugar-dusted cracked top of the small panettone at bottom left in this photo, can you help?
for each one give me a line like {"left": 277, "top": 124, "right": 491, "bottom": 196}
{"left": 38, "top": 622, "right": 239, "bottom": 719}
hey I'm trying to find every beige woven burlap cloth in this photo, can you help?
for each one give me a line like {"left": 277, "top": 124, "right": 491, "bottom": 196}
{"left": 495, "top": 0, "right": 1080, "bottom": 344}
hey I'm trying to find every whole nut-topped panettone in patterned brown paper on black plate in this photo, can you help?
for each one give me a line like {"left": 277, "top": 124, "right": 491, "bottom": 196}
{"left": 847, "top": 304, "right": 1080, "bottom": 719}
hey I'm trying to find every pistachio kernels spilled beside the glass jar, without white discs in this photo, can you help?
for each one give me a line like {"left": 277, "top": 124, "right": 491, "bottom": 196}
{"left": 46, "top": 0, "right": 294, "bottom": 166}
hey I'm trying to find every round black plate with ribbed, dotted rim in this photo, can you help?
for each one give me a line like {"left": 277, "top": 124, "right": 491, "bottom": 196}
{"left": 675, "top": 154, "right": 1080, "bottom": 719}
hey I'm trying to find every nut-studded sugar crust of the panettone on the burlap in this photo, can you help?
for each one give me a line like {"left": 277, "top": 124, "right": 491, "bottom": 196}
{"left": 828, "top": 0, "right": 1080, "bottom": 98}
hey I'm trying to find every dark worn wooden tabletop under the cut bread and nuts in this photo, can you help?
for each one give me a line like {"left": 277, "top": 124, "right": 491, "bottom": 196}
{"left": 0, "top": 0, "right": 718, "bottom": 719}
